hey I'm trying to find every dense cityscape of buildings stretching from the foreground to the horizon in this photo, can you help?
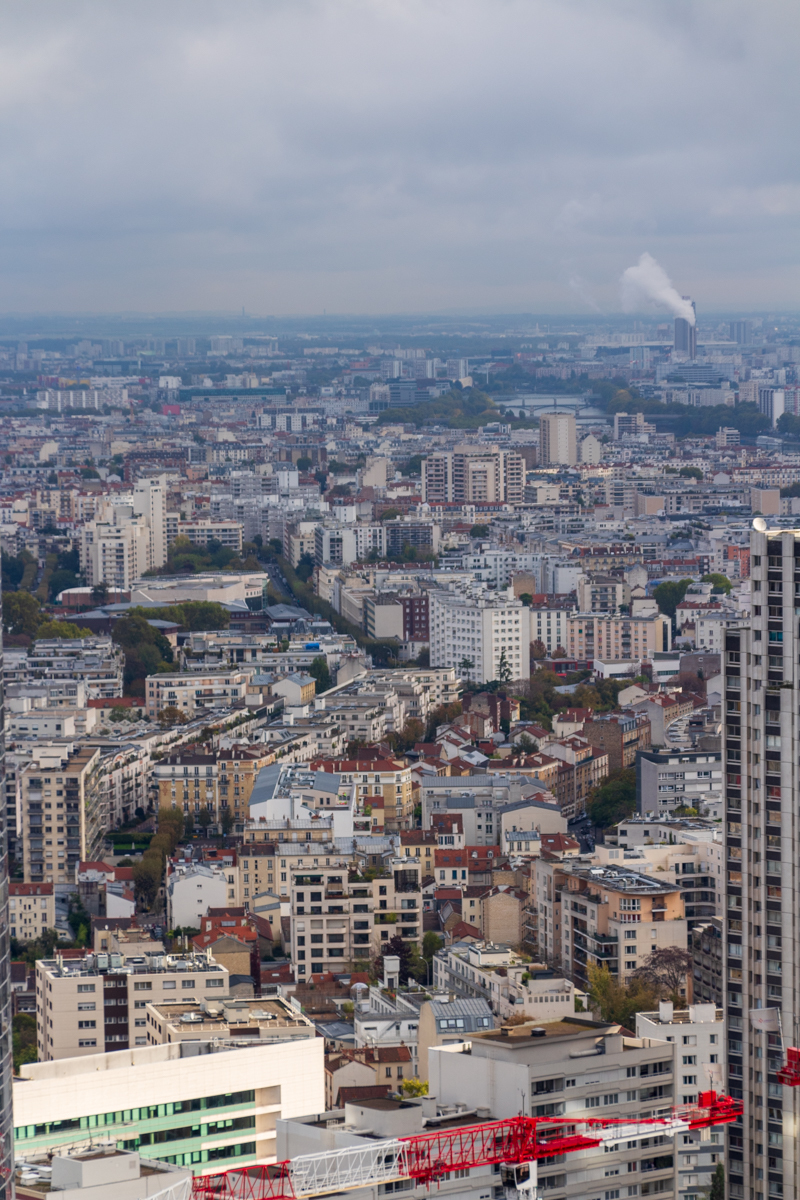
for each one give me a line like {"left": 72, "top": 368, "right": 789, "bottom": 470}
{"left": 0, "top": 298, "right": 800, "bottom": 1200}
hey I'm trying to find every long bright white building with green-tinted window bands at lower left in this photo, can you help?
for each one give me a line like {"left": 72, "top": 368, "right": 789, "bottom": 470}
{"left": 13, "top": 1036, "right": 325, "bottom": 1176}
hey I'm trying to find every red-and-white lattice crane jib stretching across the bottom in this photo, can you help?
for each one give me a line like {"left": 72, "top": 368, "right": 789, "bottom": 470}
{"left": 192, "top": 1092, "right": 742, "bottom": 1200}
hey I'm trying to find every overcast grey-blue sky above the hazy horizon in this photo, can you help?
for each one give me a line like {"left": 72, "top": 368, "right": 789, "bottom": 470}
{"left": 0, "top": 0, "right": 800, "bottom": 317}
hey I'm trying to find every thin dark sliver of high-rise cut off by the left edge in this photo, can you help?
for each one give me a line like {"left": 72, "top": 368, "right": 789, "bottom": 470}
{"left": 0, "top": 580, "right": 14, "bottom": 1200}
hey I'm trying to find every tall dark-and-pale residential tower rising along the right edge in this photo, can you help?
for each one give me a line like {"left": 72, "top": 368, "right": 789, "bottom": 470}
{"left": 722, "top": 518, "right": 800, "bottom": 1200}
